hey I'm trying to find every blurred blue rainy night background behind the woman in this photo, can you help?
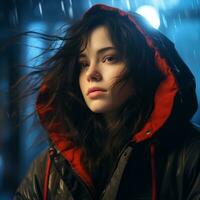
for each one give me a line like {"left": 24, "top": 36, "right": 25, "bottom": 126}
{"left": 0, "top": 0, "right": 200, "bottom": 200}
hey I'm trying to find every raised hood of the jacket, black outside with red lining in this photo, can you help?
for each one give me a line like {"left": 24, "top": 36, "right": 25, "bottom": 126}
{"left": 37, "top": 5, "right": 196, "bottom": 185}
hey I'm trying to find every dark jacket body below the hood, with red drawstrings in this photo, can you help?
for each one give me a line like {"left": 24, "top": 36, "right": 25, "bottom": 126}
{"left": 15, "top": 124, "right": 200, "bottom": 200}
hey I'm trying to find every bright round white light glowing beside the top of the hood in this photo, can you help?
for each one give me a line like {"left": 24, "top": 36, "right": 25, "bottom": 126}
{"left": 136, "top": 5, "right": 160, "bottom": 29}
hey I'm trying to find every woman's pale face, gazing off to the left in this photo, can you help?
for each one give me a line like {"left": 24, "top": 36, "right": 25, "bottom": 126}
{"left": 79, "top": 26, "right": 132, "bottom": 117}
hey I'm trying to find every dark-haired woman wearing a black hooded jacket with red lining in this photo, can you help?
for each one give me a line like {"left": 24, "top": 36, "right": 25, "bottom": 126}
{"left": 15, "top": 5, "right": 200, "bottom": 200}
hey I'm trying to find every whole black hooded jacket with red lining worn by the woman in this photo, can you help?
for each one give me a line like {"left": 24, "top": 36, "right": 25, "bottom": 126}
{"left": 15, "top": 5, "right": 200, "bottom": 200}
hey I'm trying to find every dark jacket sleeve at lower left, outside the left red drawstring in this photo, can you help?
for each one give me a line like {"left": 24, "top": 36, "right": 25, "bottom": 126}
{"left": 14, "top": 151, "right": 47, "bottom": 200}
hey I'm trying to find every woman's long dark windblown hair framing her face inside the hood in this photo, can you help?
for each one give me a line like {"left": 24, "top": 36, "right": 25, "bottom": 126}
{"left": 19, "top": 7, "right": 164, "bottom": 193}
